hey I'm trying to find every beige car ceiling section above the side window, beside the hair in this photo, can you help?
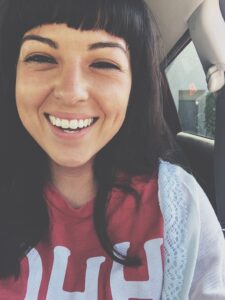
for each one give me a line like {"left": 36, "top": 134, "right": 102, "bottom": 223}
{"left": 145, "top": 0, "right": 206, "bottom": 54}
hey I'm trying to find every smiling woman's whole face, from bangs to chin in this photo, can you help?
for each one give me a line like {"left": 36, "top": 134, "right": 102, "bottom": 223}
{"left": 16, "top": 24, "right": 131, "bottom": 167}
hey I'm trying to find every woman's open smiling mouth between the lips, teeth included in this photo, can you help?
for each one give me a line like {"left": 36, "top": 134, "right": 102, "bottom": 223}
{"left": 46, "top": 114, "right": 97, "bottom": 131}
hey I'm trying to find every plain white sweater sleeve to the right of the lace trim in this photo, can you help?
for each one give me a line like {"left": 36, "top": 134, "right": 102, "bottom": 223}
{"left": 190, "top": 180, "right": 225, "bottom": 300}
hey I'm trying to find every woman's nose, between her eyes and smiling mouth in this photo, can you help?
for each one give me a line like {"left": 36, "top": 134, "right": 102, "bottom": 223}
{"left": 54, "top": 65, "right": 89, "bottom": 104}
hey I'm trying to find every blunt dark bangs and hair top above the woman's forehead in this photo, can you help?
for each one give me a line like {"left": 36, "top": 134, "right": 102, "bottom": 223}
{"left": 3, "top": 0, "right": 148, "bottom": 63}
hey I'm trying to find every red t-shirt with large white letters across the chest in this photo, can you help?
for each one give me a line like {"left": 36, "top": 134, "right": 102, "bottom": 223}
{"left": 0, "top": 177, "right": 163, "bottom": 300}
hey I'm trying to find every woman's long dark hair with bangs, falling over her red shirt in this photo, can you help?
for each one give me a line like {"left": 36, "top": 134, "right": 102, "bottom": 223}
{"left": 0, "top": 0, "right": 176, "bottom": 278}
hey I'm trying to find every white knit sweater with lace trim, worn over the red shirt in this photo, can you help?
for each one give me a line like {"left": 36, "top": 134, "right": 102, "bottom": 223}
{"left": 159, "top": 161, "right": 225, "bottom": 300}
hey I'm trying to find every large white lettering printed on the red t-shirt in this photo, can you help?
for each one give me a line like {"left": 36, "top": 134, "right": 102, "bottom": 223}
{"left": 25, "top": 238, "right": 163, "bottom": 300}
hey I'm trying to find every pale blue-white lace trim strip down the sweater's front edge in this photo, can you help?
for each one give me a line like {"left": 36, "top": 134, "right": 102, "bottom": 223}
{"left": 159, "top": 162, "right": 188, "bottom": 300}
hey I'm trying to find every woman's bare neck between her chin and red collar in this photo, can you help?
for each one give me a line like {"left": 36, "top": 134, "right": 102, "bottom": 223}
{"left": 51, "top": 162, "right": 96, "bottom": 207}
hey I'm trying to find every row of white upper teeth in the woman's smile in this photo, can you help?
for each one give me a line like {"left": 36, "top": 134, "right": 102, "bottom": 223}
{"left": 49, "top": 115, "right": 94, "bottom": 129}
